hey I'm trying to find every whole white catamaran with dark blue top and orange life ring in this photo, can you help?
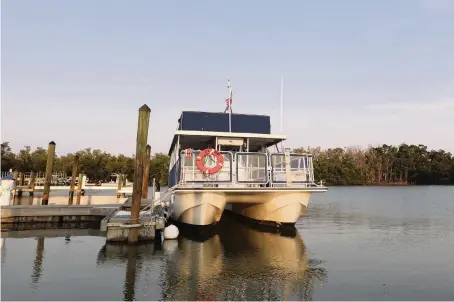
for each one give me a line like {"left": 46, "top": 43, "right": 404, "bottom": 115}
{"left": 163, "top": 82, "right": 327, "bottom": 226}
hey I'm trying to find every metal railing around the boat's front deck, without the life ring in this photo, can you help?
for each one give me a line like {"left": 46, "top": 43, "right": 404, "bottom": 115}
{"left": 169, "top": 150, "right": 316, "bottom": 187}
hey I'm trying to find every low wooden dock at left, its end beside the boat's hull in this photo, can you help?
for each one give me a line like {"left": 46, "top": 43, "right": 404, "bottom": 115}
{"left": 1, "top": 198, "right": 167, "bottom": 242}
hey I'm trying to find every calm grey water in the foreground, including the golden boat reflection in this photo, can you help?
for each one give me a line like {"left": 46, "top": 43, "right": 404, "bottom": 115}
{"left": 1, "top": 187, "right": 454, "bottom": 300}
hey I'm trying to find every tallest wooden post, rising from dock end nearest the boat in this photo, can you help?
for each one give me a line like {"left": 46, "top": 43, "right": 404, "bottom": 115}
{"left": 128, "top": 105, "right": 151, "bottom": 243}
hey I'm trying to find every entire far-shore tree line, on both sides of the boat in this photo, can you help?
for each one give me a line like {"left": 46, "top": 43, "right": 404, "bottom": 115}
{"left": 1, "top": 142, "right": 454, "bottom": 186}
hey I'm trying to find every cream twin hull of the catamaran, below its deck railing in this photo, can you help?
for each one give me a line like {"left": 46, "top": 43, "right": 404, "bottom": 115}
{"left": 167, "top": 188, "right": 326, "bottom": 226}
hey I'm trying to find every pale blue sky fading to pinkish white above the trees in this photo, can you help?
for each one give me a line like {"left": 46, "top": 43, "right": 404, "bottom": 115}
{"left": 1, "top": 0, "right": 454, "bottom": 155}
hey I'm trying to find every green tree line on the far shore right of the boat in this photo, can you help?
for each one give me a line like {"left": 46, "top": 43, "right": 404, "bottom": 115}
{"left": 294, "top": 144, "right": 454, "bottom": 185}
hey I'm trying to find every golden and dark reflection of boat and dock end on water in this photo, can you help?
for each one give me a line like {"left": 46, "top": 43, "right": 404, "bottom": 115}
{"left": 98, "top": 217, "right": 326, "bottom": 301}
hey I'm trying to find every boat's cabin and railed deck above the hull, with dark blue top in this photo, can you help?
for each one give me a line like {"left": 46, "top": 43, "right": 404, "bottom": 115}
{"left": 168, "top": 111, "right": 314, "bottom": 187}
